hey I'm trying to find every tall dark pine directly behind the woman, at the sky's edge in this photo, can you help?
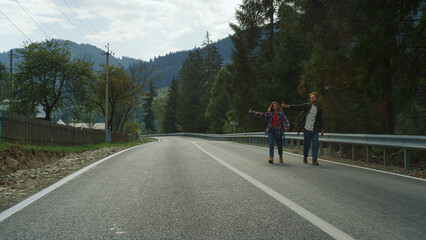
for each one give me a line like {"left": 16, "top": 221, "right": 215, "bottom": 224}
{"left": 227, "top": 0, "right": 283, "bottom": 131}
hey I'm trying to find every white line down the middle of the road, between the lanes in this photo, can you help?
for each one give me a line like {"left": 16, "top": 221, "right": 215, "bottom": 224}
{"left": 191, "top": 141, "right": 354, "bottom": 240}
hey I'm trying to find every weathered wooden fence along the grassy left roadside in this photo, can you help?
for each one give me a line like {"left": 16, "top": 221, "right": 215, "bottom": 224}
{"left": 0, "top": 112, "right": 132, "bottom": 145}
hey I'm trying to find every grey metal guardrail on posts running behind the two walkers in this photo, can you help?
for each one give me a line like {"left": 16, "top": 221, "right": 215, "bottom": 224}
{"left": 140, "top": 132, "right": 426, "bottom": 169}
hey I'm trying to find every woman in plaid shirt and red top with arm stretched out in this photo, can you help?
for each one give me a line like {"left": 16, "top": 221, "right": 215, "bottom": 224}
{"left": 249, "top": 101, "right": 290, "bottom": 164}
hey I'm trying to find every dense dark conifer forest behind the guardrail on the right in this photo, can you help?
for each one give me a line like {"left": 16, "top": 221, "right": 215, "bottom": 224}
{"left": 160, "top": 0, "right": 426, "bottom": 135}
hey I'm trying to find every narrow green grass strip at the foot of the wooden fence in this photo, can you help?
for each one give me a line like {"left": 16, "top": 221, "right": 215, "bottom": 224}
{"left": 0, "top": 138, "right": 156, "bottom": 152}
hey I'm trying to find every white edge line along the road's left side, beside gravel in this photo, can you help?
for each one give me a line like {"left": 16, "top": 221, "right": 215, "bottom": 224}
{"left": 0, "top": 142, "right": 159, "bottom": 223}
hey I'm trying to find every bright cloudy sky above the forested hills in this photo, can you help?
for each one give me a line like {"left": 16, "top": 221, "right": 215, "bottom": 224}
{"left": 0, "top": 0, "right": 242, "bottom": 60}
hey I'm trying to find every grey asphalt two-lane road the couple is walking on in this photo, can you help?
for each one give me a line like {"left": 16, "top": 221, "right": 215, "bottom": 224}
{"left": 0, "top": 137, "right": 426, "bottom": 239}
